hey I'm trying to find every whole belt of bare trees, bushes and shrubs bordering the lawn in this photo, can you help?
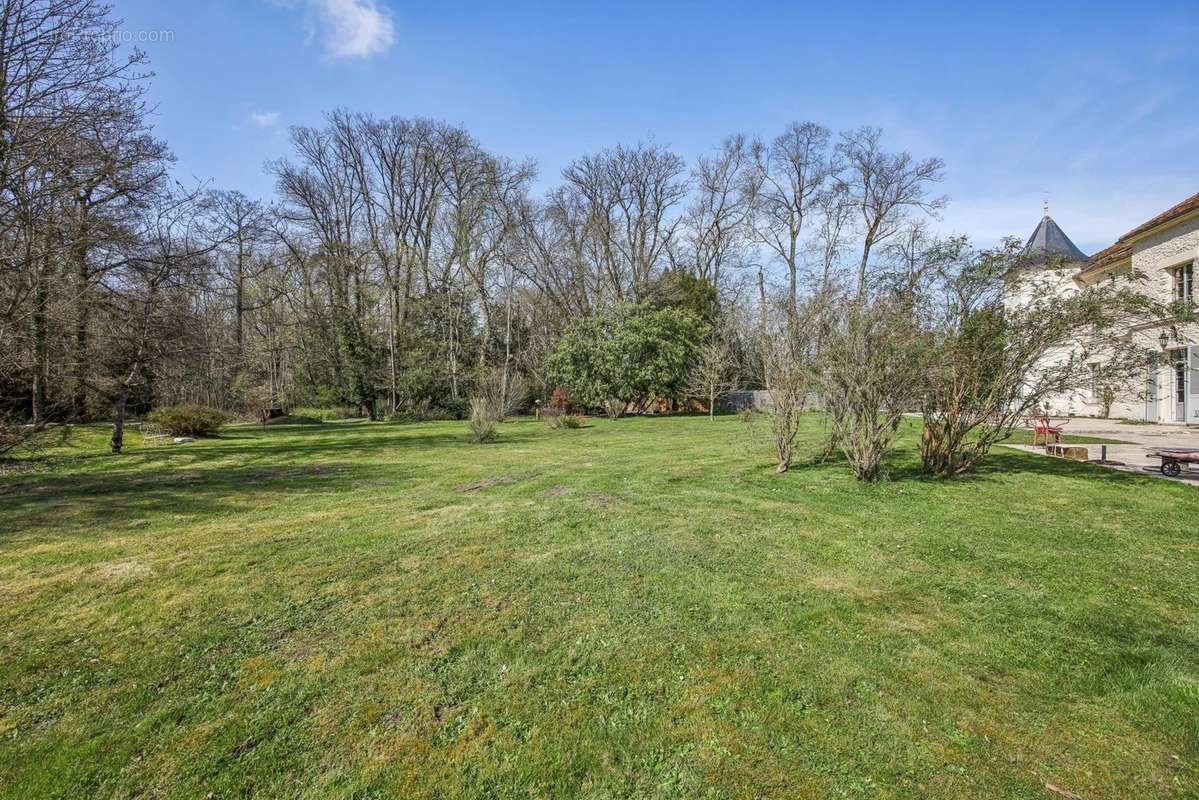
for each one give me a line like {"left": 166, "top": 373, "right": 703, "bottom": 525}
{"left": 0, "top": 0, "right": 1155, "bottom": 477}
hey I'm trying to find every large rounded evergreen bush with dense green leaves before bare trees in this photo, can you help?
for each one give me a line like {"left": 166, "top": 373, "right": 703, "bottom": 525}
{"left": 547, "top": 302, "right": 707, "bottom": 417}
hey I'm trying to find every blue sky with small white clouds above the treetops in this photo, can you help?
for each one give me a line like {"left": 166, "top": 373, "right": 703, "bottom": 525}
{"left": 113, "top": 0, "right": 1199, "bottom": 252}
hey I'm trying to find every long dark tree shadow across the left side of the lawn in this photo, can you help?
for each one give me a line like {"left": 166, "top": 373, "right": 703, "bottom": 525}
{"left": 0, "top": 423, "right": 556, "bottom": 541}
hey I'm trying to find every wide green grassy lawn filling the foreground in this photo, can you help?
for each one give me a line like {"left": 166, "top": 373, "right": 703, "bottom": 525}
{"left": 0, "top": 417, "right": 1199, "bottom": 799}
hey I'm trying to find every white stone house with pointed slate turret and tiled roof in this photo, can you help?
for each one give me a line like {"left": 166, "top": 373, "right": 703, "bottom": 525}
{"left": 1004, "top": 194, "right": 1199, "bottom": 425}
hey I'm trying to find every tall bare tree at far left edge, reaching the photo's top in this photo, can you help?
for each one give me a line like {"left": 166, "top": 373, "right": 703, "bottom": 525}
{"left": 0, "top": 0, "right": 157, "bottom": 425}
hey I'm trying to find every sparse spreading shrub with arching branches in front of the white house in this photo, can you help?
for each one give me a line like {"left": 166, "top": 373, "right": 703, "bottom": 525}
{"left": 920, "top": 242, "right": 1164, "bottom": 477}
